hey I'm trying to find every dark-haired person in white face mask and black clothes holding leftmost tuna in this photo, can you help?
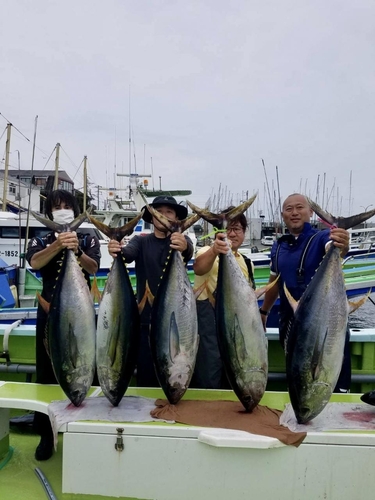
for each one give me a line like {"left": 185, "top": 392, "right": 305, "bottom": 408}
{"left": 26, "top": 189, "right": 101, "bottom": 460}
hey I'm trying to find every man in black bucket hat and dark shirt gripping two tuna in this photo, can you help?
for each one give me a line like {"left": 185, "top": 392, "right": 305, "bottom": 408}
{"left": 108, "top": 196, "right": 193, "bottom": 387}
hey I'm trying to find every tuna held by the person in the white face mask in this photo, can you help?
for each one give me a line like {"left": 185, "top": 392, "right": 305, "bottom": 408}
{"left": 33, "top": 213, "right": 95, "bottom": 406}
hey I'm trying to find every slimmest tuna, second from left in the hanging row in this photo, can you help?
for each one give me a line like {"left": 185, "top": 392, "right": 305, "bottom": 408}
{"left": 90, "top": 214, "right": 142, "bottom": 406}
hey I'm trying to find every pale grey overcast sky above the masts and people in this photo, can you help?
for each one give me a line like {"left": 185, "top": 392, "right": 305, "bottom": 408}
{"left": 0, "top": 0, "right": 375, "bottom": 221}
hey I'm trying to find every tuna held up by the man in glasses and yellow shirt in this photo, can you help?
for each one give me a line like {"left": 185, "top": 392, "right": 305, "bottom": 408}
{"left": 189, "top": 196, "right": 268, "bottom": 411}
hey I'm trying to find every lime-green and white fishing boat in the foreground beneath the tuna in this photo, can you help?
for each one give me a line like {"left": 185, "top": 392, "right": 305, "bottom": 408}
{"left": 0, "top": 346, "right": 375, "bottom": 500}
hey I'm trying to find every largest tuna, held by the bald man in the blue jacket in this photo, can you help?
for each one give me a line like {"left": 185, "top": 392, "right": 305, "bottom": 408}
{"left": 286, "top": 200, "right": 375, "bottom": 424}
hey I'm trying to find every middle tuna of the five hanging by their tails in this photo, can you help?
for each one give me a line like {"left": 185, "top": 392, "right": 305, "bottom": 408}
{"left": 147, "top": 206, "right": 200, "bottom": 404}
